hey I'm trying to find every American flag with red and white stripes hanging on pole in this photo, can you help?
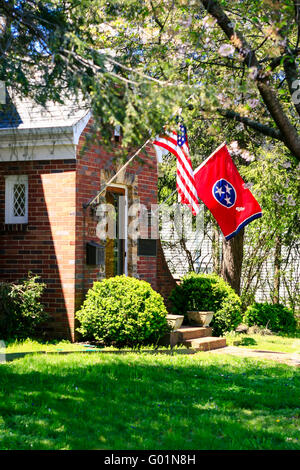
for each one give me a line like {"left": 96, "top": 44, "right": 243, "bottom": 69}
{"left": 153, "top": 124, "right": 200, "bottom": 215}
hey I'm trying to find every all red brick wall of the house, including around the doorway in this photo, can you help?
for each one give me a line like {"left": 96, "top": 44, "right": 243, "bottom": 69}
{"left": 0, "top": 122, "right": 176, "bottom": 340}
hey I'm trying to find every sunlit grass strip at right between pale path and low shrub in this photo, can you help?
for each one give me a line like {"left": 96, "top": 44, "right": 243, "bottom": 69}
{"left": 226, "top": 333, "right": 300, "bottom": 353}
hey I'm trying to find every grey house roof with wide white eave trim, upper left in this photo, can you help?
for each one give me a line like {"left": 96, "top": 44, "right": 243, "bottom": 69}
{"left": 0, "top": 92, "right": 91, "bottom": 162}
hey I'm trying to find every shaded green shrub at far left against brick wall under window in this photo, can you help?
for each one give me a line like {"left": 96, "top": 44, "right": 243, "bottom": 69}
{"left": 0, "top": 273, "right": 48, "bottom": 339}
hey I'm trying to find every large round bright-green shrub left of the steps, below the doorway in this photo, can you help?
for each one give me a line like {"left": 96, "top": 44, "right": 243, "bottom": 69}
{"left": 76, "top": 275, "right": 169, "bottom": 348}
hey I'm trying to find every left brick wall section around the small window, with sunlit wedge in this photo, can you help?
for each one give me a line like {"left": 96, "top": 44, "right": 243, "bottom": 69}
{"left": 0, "top": 160, "right": 76, "bottom": 338}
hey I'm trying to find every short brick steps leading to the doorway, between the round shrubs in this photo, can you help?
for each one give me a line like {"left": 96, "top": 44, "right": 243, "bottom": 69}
{"left": 176, "top": 326, "right": 226, "bottom": 351}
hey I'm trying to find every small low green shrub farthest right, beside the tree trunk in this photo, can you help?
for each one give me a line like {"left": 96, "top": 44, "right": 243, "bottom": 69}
{"left": 244, "top": 302, "right": 296, "bottom": 333}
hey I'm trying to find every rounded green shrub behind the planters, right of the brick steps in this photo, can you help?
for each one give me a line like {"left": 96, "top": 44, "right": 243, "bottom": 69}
{"left": 170, "top": 273, "right": 242, "bottom": 336}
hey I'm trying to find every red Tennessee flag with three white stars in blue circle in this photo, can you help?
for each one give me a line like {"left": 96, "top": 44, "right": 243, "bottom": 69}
{"left": 194, "top": 143, "right": 262, "bottom": 240}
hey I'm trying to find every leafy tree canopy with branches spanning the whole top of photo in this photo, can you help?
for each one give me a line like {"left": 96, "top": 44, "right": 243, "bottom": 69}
{"left": 0, "top": 0, "right": 300, "bottom": 294}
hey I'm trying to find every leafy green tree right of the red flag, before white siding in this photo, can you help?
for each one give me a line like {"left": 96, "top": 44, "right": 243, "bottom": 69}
{"left": 241, "top": 144, "right": 299, "bottom": 308}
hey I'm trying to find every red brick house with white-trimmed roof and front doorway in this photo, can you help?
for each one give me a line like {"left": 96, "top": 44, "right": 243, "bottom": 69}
{"left": 0, "top": 93, "right": 174, "bottom": 340}
